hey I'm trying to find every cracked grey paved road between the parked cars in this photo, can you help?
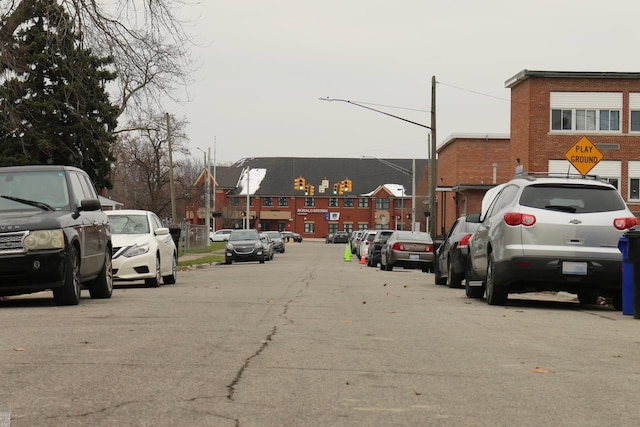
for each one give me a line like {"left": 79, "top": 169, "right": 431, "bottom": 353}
{"left": 0, "top": 242, "right": 640, "bottom": 427}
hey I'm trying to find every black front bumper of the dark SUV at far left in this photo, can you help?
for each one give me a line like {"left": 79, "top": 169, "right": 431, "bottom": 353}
{"left": 0, "top": 249, "right": 67, "bottom": 296}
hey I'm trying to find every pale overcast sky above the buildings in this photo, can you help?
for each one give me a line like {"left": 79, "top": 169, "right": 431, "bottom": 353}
{"left": 169, "top": 0, "right": 640, "bottom": 163}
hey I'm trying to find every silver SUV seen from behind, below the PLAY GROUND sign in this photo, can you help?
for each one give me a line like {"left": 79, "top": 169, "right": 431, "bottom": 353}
{"left": 466, "top": 175, "right": 638, "bottom": 308}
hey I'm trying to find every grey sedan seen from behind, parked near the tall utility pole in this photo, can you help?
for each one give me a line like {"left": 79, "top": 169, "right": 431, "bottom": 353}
{"left": 380, "top": 230, "right": 433, "bottom": 273}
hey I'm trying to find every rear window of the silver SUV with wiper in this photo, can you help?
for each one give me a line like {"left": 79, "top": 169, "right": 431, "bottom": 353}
{"left": 520, "top": 184, "right": 626, "bottom": 213}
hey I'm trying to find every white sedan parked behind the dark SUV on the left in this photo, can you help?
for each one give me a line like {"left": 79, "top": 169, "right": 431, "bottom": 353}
{"left": 105, "top": 210, "right": 178, "bottom": 287}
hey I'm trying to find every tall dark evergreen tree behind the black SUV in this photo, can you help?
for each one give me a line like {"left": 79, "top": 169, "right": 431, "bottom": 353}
{"left": 0, "top": 0, "right": 119, "bottom": 188}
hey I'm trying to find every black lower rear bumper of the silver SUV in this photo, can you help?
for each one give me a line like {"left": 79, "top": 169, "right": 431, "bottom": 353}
{"left": 494, "top": 257, "right": 622, "bottom": 295}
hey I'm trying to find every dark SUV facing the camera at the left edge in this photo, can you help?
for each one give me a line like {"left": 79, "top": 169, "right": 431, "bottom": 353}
{"left": 0, "top": 165, "right": 113, "bottom": 305}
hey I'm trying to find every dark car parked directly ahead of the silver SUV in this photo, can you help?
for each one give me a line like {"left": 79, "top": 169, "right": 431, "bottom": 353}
{"left": 433, "top": 213, "right": 480, "bottom": 288}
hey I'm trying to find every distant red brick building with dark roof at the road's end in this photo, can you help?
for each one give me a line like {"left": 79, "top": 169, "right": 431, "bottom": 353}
{"left": 185, "top": 157, "right": 428, "bottom": 238}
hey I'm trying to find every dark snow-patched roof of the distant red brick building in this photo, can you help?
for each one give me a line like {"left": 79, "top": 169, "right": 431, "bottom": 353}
{"left": 216, "top": 157, "right": 427, "bottom": 197}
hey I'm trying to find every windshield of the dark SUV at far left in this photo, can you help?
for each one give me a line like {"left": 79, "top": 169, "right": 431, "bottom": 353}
{"left": 0, "top": 171, "right": 69, "bottom": 211}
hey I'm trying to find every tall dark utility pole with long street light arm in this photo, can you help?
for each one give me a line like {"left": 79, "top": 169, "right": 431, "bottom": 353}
{"left": 319, "top": 85, "right": 436, "bottom": 237}
